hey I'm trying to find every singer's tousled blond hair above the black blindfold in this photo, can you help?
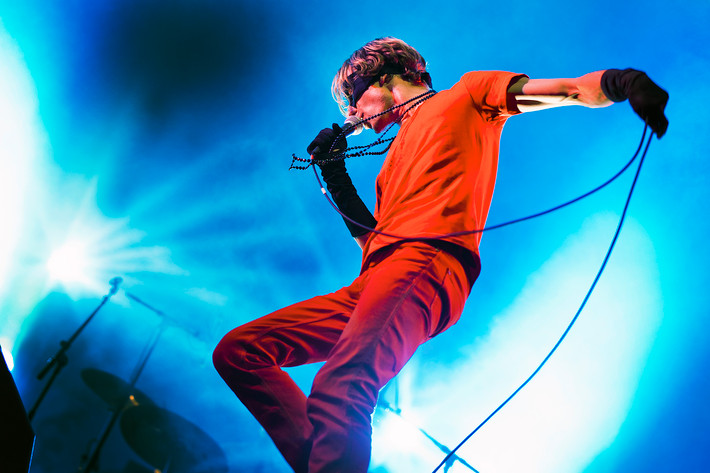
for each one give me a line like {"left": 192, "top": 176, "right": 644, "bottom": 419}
{"left": 330, "top": 37, "right": 426, "bottom": 115}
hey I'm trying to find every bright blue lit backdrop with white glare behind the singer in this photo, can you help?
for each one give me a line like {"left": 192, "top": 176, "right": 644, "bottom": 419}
{"left": 0, "top": 0, "right": 710, "bottom": 473}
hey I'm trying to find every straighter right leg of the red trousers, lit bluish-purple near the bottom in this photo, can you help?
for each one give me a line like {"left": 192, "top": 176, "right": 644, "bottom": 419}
{"left": 307, "top": 242, "right": 470, "bottom": 473}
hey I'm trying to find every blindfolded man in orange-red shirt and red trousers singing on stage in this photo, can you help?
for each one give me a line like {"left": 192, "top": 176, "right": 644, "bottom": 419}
{"left": 214, "top": 38, "right": 668, "bottom": 473}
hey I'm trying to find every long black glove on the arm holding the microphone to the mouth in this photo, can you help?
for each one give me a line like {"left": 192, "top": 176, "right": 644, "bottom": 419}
{"left": 306, "top": 123, "right": 377, "bottom": 238}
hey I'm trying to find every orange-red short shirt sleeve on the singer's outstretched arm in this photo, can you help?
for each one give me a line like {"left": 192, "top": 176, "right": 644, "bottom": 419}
{"left": 462, "top": 71, "right": 527, "bottom": 120}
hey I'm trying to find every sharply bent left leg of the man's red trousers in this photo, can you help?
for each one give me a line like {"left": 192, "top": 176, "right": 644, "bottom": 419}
{"left": 213, "top": 280, "right": 359, "bottom": 473}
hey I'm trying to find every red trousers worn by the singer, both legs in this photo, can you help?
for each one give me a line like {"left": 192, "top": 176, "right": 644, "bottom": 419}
{"left": 213, "top": 242, "right": 477, "bottom": 473}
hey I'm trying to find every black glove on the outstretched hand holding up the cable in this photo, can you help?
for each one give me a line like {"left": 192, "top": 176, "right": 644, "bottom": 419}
{"left": 601, "top": 69, "right": 668, "bottom": 138}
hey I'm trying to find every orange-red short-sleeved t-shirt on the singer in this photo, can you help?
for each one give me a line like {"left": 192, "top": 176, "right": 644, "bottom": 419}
{"left": 363, "top": 71, "right": 524, "bottom": 268}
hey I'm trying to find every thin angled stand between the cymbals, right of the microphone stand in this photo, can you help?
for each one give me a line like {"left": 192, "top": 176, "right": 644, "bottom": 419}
{"left": 77, "top": 292, "right": 168, "bottom": 473}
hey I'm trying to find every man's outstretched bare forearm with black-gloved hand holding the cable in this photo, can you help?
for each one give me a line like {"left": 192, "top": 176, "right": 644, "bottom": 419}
{"left": 508, "top": 69, "right": 668, "bottom": 138}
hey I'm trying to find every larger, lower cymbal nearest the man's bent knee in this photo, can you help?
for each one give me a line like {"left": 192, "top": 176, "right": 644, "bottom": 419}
{"left": 121, "top": 405, "right": 228, "bottom": 473}
